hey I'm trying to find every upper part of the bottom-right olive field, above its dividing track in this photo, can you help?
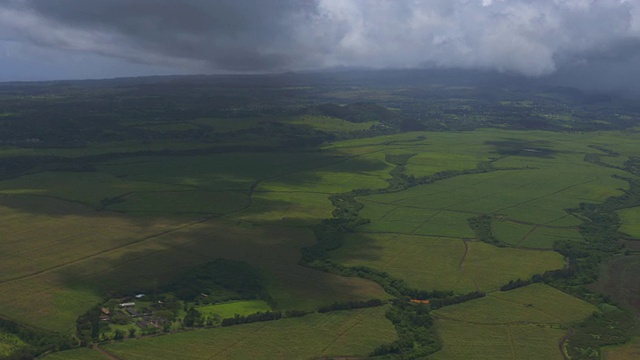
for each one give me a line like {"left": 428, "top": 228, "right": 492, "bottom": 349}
{"left": 434, "top": 284, "right": 597, "bottom": 325}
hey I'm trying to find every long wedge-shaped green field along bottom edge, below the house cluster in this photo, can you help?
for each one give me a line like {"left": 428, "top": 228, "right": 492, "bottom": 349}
{"left": 104, "top": 307, "right": 396, "bottom": 360}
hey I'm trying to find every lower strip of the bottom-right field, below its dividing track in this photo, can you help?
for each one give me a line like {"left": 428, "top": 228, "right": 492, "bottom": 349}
{"left": 430, "top": 320, "right": 565, "bottom": 360}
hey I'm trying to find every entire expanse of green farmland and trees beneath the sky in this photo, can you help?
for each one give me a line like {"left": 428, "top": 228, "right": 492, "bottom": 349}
{"left": 0, "top": 74, "right": 640, "bottom": 360}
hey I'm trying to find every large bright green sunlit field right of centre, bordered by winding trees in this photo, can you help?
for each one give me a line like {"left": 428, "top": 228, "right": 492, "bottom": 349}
{"left": 361, "top": 165, "right": 626, "bottom": 225}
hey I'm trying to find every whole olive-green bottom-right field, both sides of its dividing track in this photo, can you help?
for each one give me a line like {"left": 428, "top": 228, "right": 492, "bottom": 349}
{"left": 433, "top": 284, "right": 597, "bottom": 359}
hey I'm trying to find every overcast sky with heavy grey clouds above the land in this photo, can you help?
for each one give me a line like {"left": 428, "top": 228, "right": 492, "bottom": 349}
{"left": 0, "top": 0, "right": 640, "bottom": 88}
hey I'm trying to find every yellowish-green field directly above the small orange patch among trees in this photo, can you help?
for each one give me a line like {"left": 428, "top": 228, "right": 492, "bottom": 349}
{"left": 332, "top": 234, "right": 564, "bottom": 292}
